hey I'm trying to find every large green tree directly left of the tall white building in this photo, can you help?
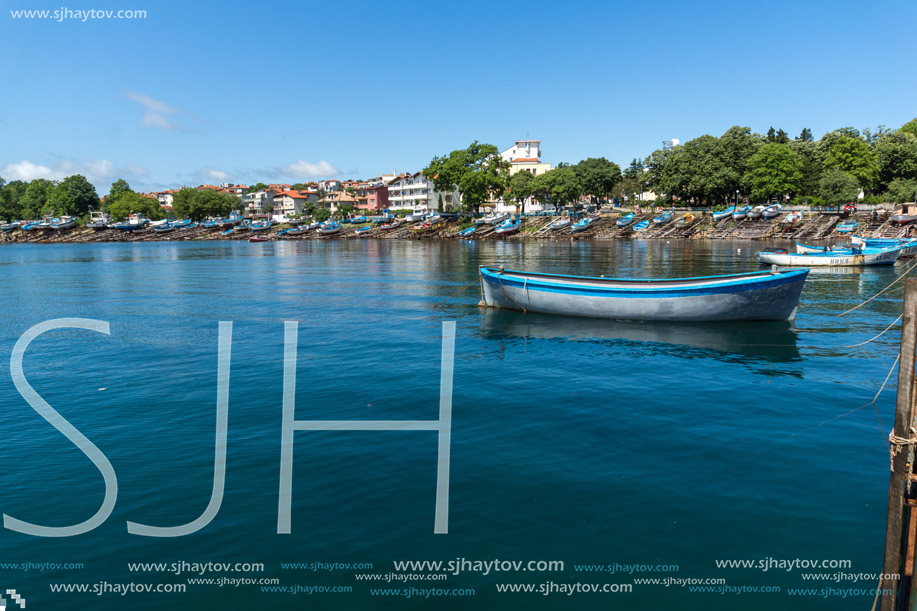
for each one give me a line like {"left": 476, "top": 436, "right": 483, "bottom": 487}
{"left": 423, "top": 140, "right": 510, "bottom": 212}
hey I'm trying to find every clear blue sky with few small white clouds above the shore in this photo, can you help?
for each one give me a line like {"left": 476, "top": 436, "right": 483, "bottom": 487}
{"left": 0, "top": 0, "right": 917, "bottom": 193}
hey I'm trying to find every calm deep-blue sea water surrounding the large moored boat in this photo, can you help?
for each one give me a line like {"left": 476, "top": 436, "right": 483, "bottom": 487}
{"left": 0, "top": 241, "right": 902, "bottom": 610}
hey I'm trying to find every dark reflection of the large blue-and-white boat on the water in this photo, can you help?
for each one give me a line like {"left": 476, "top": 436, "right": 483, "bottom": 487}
{"left": 481, "top": 309, "right": 802, "bottom": 377}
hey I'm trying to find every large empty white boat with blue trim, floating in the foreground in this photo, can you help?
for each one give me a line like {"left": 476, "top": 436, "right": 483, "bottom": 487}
{"left": 480, "top": 267, "right": 809, "bottom": 322}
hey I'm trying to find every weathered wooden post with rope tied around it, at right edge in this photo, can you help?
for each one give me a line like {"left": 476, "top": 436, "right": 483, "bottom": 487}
{"left": 881, "top": 278, "right": 917, "bottom": 611}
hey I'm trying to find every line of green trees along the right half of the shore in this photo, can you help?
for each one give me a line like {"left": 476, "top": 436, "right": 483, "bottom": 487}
{"left": 423, "top": 119, "right": 917, "bottom": 211}
